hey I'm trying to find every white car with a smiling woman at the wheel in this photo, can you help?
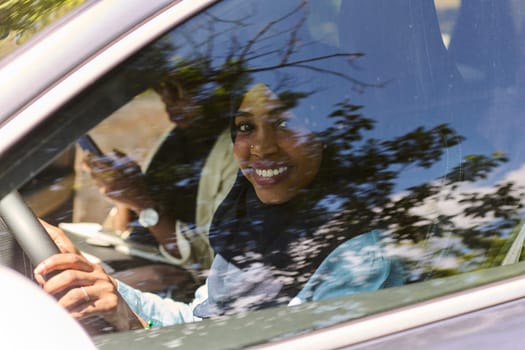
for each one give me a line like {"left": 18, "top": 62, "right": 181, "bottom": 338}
{"left": 0, "top": 0, "right": 525, "bottom": 349}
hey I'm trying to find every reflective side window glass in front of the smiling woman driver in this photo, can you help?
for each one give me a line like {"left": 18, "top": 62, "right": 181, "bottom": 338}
{"left": 20, "top": 0, "right": 524, "bottom": 336}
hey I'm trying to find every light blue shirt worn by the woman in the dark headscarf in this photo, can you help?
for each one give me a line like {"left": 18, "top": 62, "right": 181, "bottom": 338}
{"left": 118, "top": 231, "right": 403, "bottom": 326}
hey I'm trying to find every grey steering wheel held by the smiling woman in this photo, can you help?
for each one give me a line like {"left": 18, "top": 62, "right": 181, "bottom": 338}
{"left": 0, "top": 191, "right": 112, "bottom": 335}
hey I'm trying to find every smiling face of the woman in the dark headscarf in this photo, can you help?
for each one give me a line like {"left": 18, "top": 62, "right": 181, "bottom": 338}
{"left": 234, "top": 84, "right": 322, "bottom": 204}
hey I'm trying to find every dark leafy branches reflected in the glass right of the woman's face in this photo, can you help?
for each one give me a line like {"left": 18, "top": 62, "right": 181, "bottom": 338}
{"left": 312, "top": 97, "right": 523, "bottom": 278}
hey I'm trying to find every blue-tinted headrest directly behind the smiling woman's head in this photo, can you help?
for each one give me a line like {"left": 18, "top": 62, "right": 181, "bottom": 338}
{"left": 339, "top": 0, "right": 461, "bottom": 105}
